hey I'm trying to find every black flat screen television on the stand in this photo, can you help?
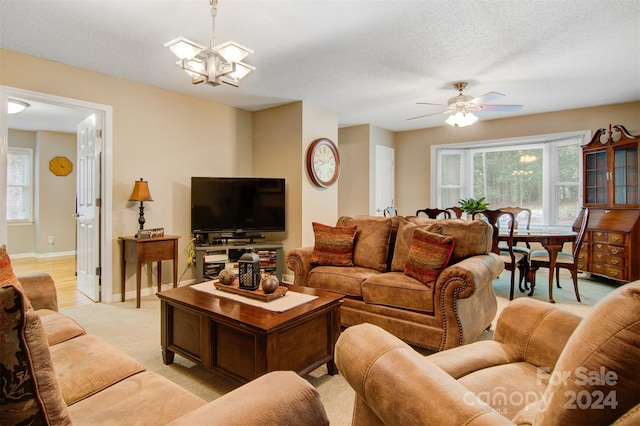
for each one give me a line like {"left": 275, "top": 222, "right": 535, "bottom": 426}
{"left": 191, "top": 177, "right": 285, "bottom": 236}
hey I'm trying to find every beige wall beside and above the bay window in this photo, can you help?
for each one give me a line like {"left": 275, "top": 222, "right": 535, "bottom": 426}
{"left": 395, "top": 102, "right": 640, "bottom": 215}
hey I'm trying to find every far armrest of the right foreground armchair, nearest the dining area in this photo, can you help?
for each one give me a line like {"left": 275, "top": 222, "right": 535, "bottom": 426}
{"left": 493, "top": 298, "right": 582, "bottom": 371}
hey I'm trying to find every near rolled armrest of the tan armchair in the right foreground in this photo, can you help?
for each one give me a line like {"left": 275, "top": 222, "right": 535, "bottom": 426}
{"left": 336, "top": 324, "right": 512, "bottom": 425}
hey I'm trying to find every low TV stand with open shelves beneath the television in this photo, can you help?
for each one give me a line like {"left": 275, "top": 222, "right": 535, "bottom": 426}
{"left": 195, "top": 236, "right": 284, "bottom": 283}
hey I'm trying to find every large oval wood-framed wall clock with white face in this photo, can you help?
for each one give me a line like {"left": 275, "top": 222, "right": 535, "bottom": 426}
{"left": 307, "top": 138, "right": 340, "bottom": 188}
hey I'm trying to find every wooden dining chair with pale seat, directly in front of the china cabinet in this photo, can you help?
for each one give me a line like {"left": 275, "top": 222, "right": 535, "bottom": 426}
{"left": 529, "top": 208, "right": 589, "bottom": 302}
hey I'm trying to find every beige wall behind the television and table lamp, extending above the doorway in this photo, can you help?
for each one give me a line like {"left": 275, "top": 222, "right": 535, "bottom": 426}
{"left": 0, "top": 49, "right": 253, "bottom": 300}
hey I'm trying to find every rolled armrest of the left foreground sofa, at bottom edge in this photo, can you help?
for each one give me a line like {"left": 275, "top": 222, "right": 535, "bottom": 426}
{"left": 170, "top": 371, "right": 329, "bottom": 426}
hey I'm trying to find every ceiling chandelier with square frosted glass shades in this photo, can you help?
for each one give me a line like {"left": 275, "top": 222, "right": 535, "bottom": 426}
{"left": 164, "top": 0, "right": 255, "bottom": 87}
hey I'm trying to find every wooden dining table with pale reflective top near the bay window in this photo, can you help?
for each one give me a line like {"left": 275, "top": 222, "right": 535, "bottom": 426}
{"left": 498, "top": 228, "right": 578, "bottom": 303}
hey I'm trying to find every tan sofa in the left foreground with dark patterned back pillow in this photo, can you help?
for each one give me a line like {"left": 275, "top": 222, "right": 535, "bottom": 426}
{"left": 0, "top": 272, "right": 329, "bottom": 425}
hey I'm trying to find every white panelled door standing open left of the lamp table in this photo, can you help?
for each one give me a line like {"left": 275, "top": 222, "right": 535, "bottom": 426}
{"left": 76, "top": 114, "right": 103, "bottom": 301}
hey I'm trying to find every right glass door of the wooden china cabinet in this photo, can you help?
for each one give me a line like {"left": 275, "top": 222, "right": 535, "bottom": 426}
{"left": 613, "top": 146, "right": 640, "bottom": 205}
